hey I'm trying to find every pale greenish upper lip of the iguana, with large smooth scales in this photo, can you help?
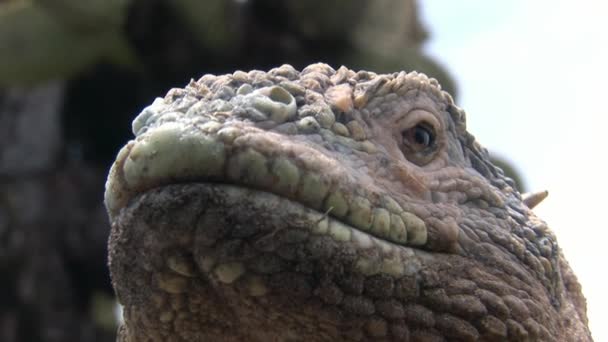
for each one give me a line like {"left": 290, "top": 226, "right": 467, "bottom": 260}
{"left": 106, "top": 121, "right": 428, "bottom": 247}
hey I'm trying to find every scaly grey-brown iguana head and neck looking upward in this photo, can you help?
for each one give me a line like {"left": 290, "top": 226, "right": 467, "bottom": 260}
{"left": 106, "top": 64, "right": 591, "bottom": 341}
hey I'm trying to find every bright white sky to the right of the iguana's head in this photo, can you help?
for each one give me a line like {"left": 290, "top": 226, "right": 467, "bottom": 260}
{"left": 419, "top": 0, "right": 608, "bottom": 341}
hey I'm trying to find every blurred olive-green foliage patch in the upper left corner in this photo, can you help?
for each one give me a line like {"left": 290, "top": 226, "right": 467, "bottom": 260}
{"left": 0, "top": 0, "right": 134, "bottom": 86}
